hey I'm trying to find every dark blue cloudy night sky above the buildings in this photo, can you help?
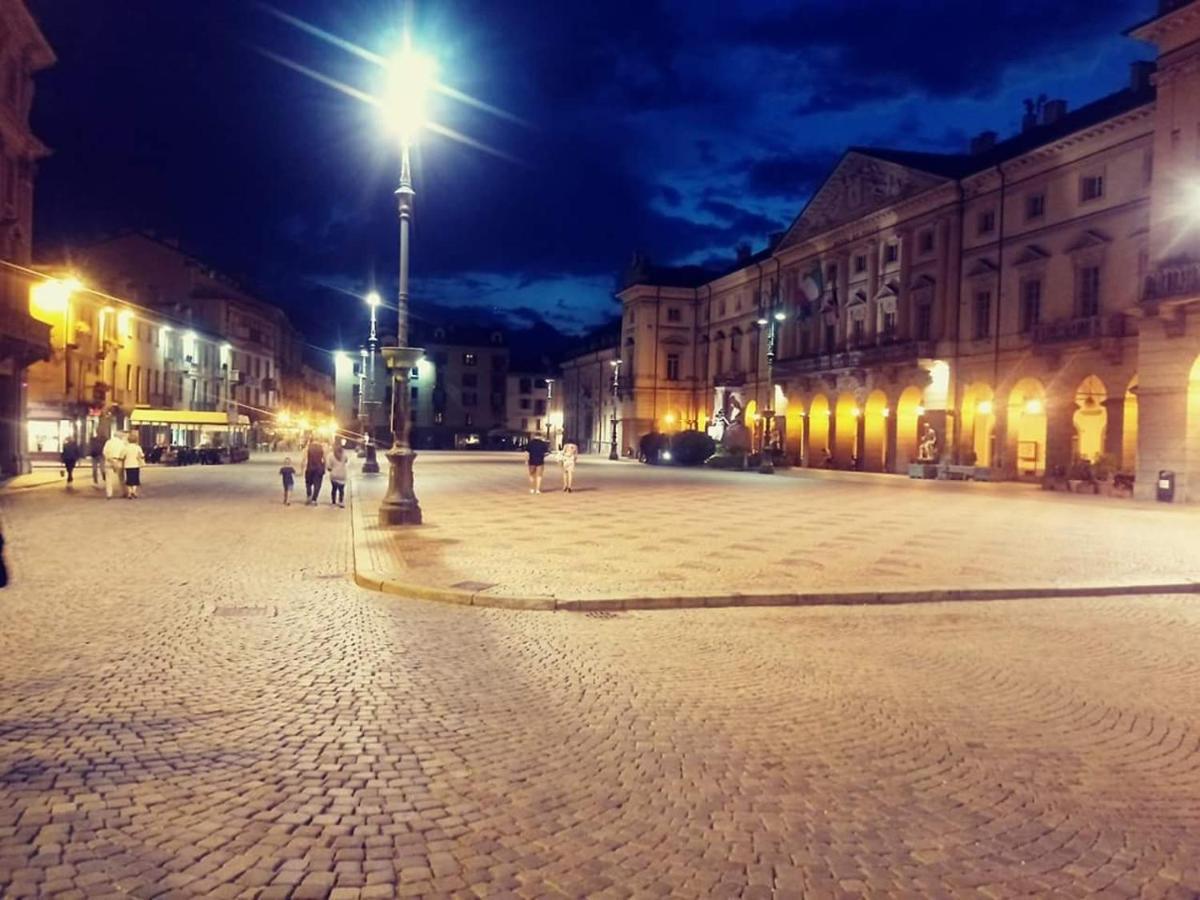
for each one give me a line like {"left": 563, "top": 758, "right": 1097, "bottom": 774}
{"left": 31, "top": 0, "right": 1154, "bottom": 347}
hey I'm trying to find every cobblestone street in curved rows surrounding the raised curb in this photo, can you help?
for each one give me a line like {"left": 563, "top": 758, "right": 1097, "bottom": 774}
{"left": 0, "top": 463, "right": 1200, "bottom": 900}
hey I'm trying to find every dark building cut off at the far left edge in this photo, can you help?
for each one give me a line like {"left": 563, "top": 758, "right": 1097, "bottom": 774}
{"left": 0, "top": 0, "right": 54, "bottom": 475}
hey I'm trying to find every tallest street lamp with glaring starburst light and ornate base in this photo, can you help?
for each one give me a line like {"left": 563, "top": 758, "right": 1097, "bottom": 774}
{"left": 379, "top": 42, "right": 433, "bottom": 526}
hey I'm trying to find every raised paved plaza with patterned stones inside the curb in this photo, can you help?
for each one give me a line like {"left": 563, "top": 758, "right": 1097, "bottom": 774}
{"left": 356, "top": 454, "right": 1200, "bottom": 600}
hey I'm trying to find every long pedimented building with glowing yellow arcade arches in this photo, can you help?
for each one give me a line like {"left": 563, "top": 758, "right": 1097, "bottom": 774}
{"left": 566, "top": 0, "right": 1200, "bottom": 500}
